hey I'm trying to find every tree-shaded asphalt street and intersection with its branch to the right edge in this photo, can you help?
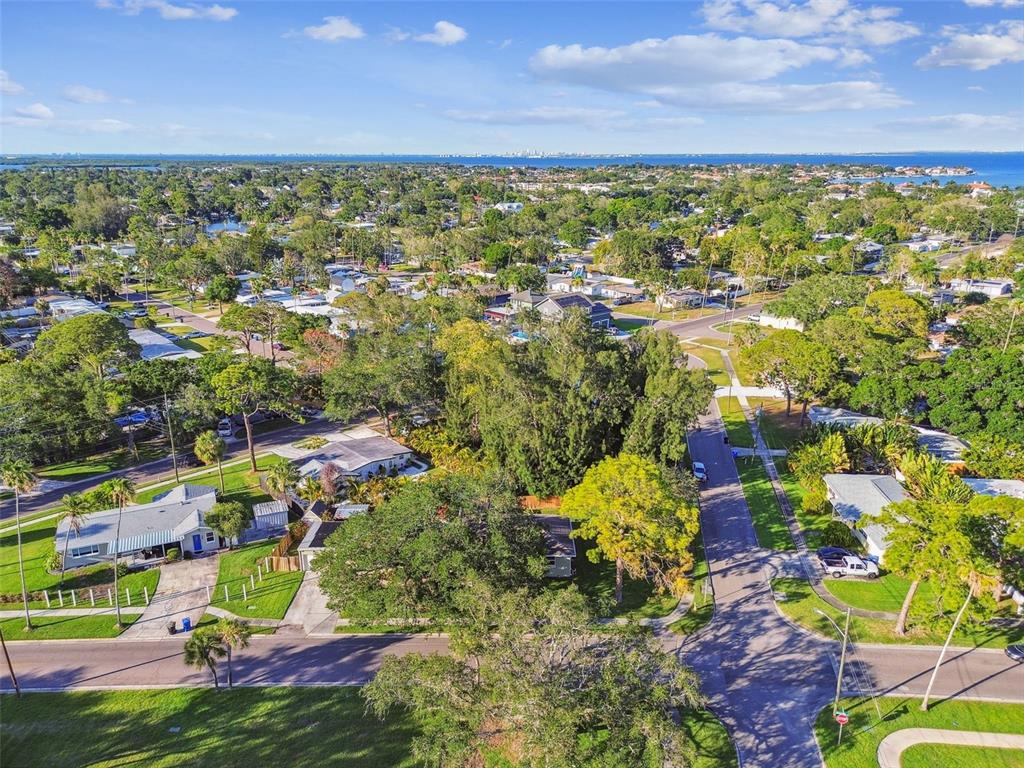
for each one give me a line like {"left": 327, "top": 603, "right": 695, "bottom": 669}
{"left": 663, "top": 401, "right": 1024, "bottom": 768}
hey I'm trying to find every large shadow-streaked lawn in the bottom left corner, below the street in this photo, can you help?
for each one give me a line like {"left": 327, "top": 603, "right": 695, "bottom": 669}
{"left": 0, "top": 688, "right": 418, "bottom": 768}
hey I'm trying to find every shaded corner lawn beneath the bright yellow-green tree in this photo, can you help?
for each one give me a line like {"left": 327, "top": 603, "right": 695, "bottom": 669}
{"left": 548, "top": 539, "right": 679, "bottom": 618}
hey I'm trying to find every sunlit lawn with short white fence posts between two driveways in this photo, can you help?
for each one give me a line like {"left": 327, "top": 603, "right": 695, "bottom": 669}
{"left": 211, "top": 541, "right": 302, "bottom": 618}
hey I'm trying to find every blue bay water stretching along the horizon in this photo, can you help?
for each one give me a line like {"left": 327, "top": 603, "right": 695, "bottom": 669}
{"left": 6, "top": 152, "right": 1024, "bottom": 186}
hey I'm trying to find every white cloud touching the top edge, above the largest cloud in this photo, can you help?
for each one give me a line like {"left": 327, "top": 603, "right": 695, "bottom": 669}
{"left": 701, "top": 0, "right": 921, "bottom": 45}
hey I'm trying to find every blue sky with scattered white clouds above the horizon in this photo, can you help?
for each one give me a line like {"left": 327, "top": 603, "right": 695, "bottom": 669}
{"left": 0, "top": 0, "right": 1024, "bottom": 154}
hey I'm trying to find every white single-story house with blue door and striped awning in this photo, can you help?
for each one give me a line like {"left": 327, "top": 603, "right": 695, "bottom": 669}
{"left": 54, "top": 484, "right": 225, "bottom": 568}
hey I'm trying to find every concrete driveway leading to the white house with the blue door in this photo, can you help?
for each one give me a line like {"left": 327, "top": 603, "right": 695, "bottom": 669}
{"left": 119, "top": 553, "right": 220, "bottom": 640}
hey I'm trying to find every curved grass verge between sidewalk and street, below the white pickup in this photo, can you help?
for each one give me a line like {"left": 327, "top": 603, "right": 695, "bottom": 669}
{"left": 772, "top": 579, "right": 1024, "bottom": 648}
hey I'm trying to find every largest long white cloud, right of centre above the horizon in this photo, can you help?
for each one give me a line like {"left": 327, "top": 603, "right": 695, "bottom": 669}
{"left": 529, "top": 34, "right": 904, "bottom": 112}
